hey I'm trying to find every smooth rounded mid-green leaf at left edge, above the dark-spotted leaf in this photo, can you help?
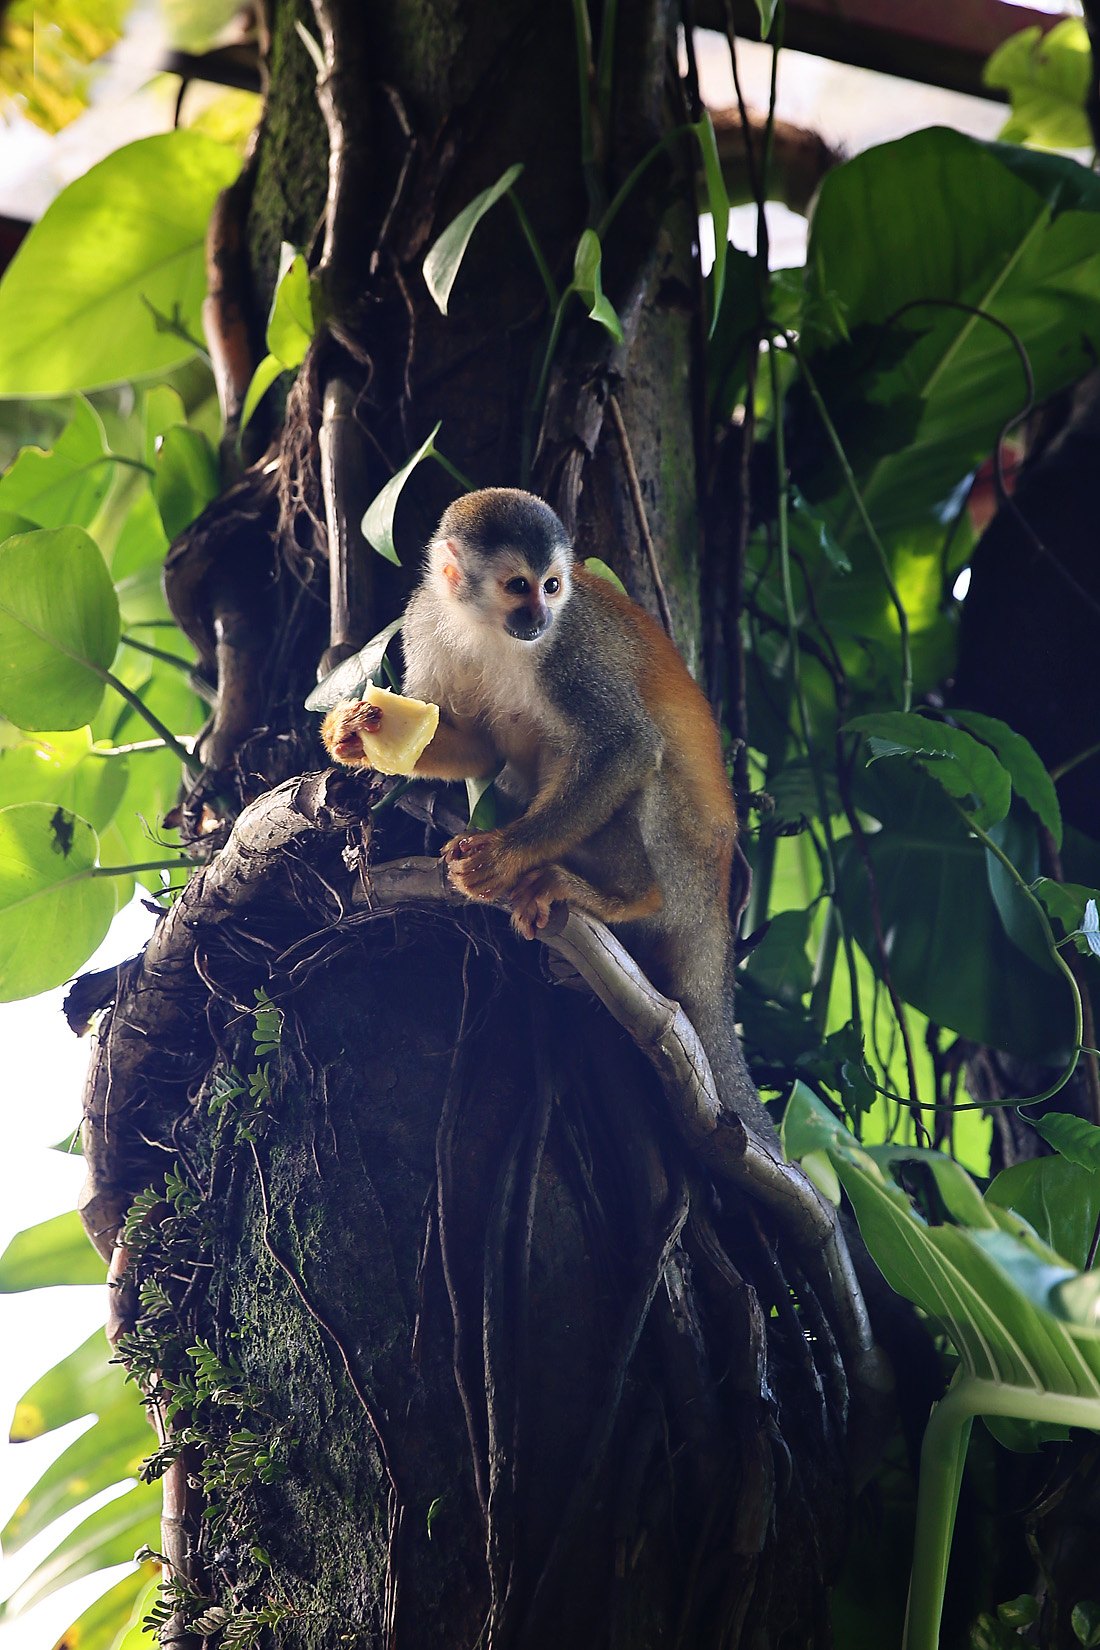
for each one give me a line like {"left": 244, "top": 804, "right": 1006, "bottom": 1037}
{"left": 0, "top": 526, "right": 119, "bottom": 729}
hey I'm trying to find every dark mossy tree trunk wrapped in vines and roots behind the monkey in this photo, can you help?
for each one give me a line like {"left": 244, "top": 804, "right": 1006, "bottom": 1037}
{"left": 84, "top": 0, "right": 879, "bottom": 1650}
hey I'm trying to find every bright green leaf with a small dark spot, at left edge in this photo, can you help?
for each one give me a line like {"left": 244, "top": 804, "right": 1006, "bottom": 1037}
{"left": 0, "top": 802, "right": 115, "bottom": 1003}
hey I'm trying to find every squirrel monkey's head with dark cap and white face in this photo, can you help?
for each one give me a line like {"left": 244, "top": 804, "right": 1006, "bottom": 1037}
{"left": 427, "top": 487, "right": 572, "bottom": 642}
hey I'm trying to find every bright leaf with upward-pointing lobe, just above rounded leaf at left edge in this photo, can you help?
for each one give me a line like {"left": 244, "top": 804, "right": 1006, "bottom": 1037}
{"left": 0, "top": 396, "right": 114, "bottom": 526}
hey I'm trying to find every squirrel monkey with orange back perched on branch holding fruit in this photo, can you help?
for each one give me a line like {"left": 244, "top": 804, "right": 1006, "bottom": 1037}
{"left": 322, "top": 487, "right": 770, "bottom": 1132}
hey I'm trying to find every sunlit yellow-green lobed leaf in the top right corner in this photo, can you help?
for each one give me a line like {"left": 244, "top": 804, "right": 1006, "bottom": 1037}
{"left": 981, "top": 17, "right": 1092, "bottom": 149}
